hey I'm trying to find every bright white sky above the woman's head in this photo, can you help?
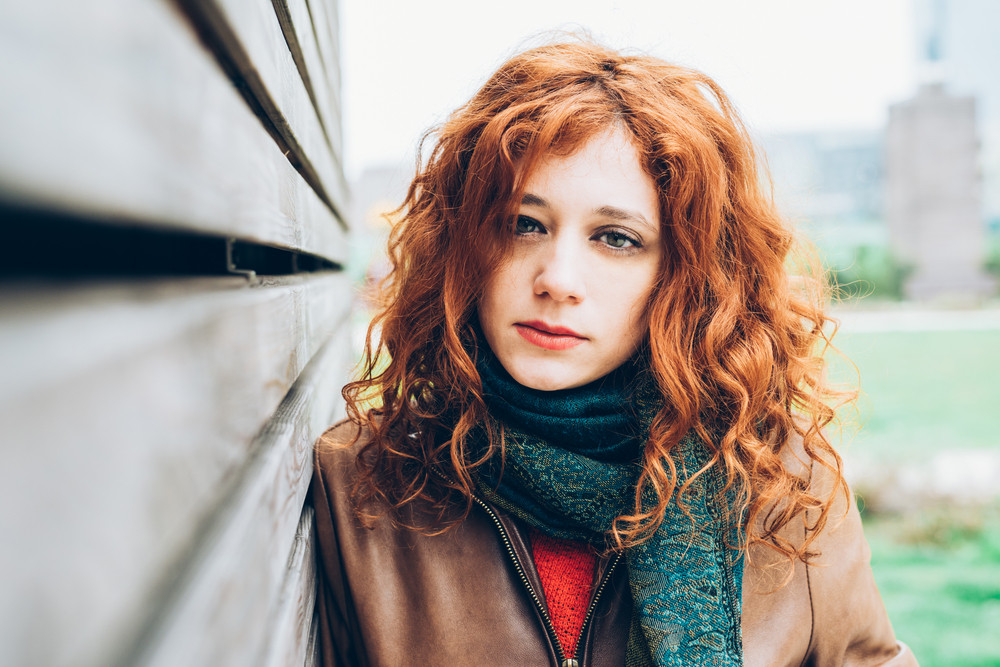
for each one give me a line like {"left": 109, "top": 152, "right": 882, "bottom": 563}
{"left": 340, "top": 0, "right": 916, "bottom": 179}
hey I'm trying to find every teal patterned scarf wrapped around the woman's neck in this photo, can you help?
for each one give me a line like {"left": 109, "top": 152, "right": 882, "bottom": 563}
{"left": 470, "top": 345, "right": 743, "bottom": 667}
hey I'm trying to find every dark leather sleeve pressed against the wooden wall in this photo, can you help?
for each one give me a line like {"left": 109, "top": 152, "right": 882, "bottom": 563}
{"left": 309, "top": 425, "right": 368, "bottom": 667}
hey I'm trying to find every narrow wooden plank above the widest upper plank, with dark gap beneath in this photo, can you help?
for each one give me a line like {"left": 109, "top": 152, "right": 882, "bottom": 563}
{"left": 177, "top": 0, "right": 347, "bottom": 224}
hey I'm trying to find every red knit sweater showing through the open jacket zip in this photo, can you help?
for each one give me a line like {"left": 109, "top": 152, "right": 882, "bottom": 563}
{"left": 531, "top": 530, "right": 597, "bottom": 656}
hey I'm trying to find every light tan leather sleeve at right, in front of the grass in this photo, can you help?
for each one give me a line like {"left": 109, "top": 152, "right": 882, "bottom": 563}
{"left": 804, "top": 466, "right": 917, "bottom": 667}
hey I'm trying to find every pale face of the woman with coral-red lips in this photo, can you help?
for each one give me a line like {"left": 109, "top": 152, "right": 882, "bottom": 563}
{"left": 479, "top": 130, "right": 662, "bottom": 391}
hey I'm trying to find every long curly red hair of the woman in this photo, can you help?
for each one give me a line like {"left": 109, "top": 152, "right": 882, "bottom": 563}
{"left": 343, "top": 40, "right": 852, "bottom": 561}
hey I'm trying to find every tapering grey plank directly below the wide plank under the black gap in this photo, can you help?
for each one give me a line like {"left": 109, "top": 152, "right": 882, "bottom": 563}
{"left": 127, "top": 320, "right": 349, "bottom": 667}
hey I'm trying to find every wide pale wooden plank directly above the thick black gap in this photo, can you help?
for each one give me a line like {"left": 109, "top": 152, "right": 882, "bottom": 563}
{"left": 0, "top": 0, "right": 346, "bottom": 263}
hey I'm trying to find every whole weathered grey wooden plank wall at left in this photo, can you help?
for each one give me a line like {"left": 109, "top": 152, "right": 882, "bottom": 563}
{"left": 0, "top": 0, "right": 353, "bottom": 667}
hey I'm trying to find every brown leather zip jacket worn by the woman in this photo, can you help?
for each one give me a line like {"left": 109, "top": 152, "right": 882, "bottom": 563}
{"left": 312, "top": 423, "right": 917, "bottom": 667}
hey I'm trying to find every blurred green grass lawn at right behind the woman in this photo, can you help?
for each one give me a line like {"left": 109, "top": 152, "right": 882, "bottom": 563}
{"left": 831, "top": 331, "right": 1000, "bottom": 667}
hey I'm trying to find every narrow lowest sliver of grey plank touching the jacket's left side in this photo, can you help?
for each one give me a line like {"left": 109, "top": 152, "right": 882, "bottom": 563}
{"left": 258, "top": 505, "right": 316, "bottom": 667}
